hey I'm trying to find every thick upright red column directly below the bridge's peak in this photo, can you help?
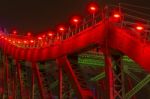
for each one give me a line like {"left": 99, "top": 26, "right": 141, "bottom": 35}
{"left": 105, "top": 50, "right": 115, "bottom": 99}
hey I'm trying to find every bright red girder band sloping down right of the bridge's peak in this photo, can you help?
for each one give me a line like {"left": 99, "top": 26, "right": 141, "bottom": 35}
{"left": 108, "top": 26, "right": 150, "bottom": 72}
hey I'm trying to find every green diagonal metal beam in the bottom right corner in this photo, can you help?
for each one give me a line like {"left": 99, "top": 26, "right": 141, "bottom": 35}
{"left": 125, "top": 74, "right": 150, "bottom": 99}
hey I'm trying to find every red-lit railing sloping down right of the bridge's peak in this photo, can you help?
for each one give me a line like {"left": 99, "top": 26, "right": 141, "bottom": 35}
{"left": 109, "top": 4, "right": 150, "bottom": 42}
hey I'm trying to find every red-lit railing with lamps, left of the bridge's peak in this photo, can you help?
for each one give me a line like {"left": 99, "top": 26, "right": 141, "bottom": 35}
{"left": 1, "top": 13, "right": 102, "bottom": 48}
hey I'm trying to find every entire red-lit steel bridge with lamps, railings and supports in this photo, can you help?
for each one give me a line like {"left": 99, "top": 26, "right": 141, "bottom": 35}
{"left": 0, "top": 2, "right": 150, "bottom": 99}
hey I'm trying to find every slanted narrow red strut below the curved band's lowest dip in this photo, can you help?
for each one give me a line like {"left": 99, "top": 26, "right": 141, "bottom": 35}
{"left": 32, "top": 62, "right": 45, "bottom": 99}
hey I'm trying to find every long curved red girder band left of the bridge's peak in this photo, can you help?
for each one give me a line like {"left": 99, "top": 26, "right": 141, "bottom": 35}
{"left": 1, "top": 22, "right": 106, "bottom": 61}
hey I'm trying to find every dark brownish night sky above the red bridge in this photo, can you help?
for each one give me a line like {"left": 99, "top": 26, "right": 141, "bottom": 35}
{"left": 0, "top": 0, "right": 150, "bottom": 33}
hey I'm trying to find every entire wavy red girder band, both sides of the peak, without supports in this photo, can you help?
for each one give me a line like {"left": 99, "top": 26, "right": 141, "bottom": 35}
{"left": 1, "top": 22, "right": 150, "bottom": 71}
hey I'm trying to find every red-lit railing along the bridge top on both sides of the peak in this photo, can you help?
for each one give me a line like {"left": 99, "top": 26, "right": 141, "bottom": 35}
{"left": 1, "top": 6, "right": 150, "bottom": 48}
